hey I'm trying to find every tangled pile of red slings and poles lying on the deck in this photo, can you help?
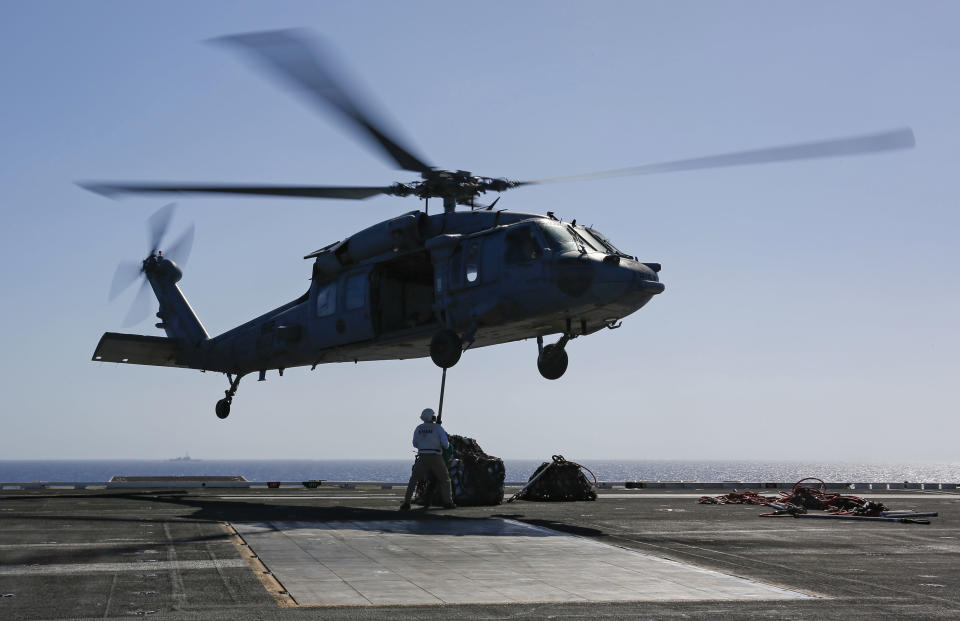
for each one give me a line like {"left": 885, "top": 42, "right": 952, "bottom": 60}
{"left": 698, "top": 477, "right": 937, "bottom": 524}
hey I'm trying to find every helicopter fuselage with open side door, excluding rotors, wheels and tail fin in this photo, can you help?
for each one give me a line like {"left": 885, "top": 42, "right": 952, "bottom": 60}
{"left": 212, "top": 212, "right": 663, "bottom": 374}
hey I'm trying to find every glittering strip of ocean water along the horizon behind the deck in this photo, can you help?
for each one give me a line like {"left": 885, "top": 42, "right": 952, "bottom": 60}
{"left": 0, "top": 459, "right": 960, "bottom": 483}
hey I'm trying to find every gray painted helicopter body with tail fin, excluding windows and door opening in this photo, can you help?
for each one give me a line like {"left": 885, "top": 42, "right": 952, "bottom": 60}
{"left": 95, "top": 211, "right": 663, "bottom": 374}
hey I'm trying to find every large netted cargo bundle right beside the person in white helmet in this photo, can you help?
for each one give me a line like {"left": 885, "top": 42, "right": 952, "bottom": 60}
{"left": 413, "top": 435, "right": 506, "bottom": 507}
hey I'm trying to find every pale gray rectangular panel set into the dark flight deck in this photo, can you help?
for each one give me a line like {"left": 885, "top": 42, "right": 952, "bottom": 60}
{"left": 233, "top": 519, "right": 811, "bottom": 606}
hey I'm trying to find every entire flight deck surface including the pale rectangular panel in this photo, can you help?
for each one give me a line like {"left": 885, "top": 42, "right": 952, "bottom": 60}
{"left": 0, "top": 488, "right": 960, "bottom": 619}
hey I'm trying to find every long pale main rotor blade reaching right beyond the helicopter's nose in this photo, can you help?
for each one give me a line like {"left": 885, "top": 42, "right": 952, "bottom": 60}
{"left": 517, "top": 128, "right": 916, "bottom": 185}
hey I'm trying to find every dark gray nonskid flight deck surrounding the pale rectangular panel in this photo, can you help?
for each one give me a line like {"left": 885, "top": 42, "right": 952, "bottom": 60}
{"left": 0, "top": 489, "right": 960, "bottom": 621}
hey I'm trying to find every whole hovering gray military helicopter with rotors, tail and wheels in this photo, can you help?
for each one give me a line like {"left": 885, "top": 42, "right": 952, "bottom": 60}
{"left": 79, "top": 30, "right": 915, "bottom": 419}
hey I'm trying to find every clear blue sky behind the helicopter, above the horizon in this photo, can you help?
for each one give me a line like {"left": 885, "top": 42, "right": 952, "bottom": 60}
{"left": 0, "top": 0, "right": 960, "bottom": 460}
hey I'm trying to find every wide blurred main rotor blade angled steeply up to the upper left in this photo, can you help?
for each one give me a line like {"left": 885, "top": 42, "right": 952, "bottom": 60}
{"left": 212, "top": 30, "right": 430, "bottom": 173}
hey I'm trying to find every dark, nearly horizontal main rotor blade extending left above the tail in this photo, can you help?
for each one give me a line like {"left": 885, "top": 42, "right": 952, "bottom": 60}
{"left": 77, "top": 182, "right": 392, "bottom": 200}
